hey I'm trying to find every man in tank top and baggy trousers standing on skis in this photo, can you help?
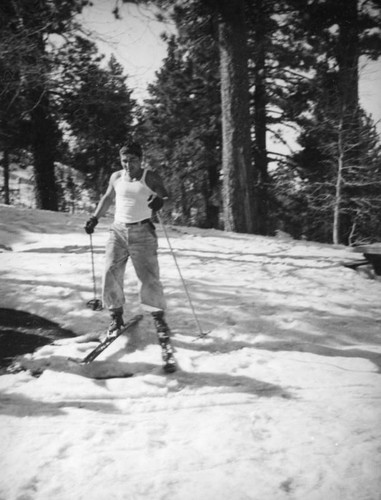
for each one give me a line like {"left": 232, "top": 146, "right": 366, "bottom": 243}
{"left": 85, "top": 142, "right": 175, "bottom": 371}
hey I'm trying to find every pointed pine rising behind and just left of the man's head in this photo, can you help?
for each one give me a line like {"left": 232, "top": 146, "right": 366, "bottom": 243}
{"left": 61, "top": 37, "right": 136, "bottom": 197}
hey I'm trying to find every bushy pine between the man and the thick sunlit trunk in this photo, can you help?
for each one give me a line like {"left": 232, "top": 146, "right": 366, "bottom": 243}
{"left": 140, "top": 37, "right": 221, "bottom": 227}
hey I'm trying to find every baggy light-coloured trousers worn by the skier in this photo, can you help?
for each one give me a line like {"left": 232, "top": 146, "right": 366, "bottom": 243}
{"left": 103, "top": 222, "right": 166, "bottom": 311}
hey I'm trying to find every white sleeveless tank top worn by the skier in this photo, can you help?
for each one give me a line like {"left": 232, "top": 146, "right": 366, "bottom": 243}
{"left": 114, "top": 170, "right": 153, "bottom": 224}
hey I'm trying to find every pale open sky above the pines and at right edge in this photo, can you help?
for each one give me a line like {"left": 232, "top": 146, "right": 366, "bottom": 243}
{"left": 81, "top": 0, "right": 381, "bottom": 134}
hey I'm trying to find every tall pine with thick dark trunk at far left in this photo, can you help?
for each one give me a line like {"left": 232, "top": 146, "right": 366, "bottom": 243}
{"left": 0, "top": 0, "right": 87, "bottom": 210}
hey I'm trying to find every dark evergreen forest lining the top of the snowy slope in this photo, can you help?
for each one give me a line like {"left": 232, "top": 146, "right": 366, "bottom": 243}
{"left": 0, "top": 0, "right": 381, "bottom": 245}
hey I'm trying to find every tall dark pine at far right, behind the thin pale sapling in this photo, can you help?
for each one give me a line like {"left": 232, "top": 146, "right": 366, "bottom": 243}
{"left": 268, "top": 0, "right": 381, "bottom": 243}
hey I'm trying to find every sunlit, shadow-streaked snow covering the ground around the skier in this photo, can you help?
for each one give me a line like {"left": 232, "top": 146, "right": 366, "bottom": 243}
{"left": 0, "top": 206, "right": 381, "bottom": 500}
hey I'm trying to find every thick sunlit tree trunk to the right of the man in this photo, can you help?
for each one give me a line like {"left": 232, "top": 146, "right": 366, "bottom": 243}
{"left": 219, "top": 0, "right": 258, "bottom": 233}
